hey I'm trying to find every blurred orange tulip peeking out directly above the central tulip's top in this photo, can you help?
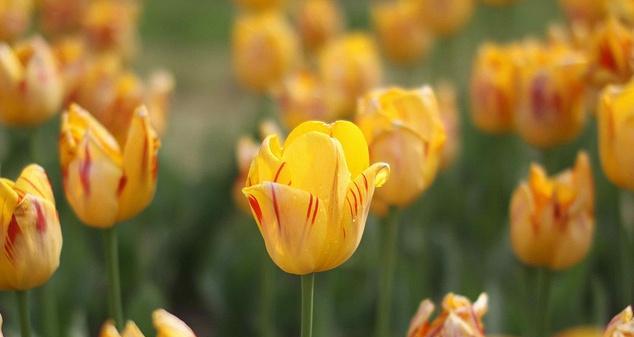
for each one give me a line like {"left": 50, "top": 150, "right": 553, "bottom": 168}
{"left": 274, "top": 70, "right": 336, "bottom": 129}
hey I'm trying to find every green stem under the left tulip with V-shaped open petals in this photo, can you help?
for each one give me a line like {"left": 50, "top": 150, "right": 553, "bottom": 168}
{"left": 103, "top": 226, "right": 123, "bottom": 330}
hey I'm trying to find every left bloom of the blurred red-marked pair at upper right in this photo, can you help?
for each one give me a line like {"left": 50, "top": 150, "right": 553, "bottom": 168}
{"left": 470, "top": 43, "right": 518, "bottom": 133}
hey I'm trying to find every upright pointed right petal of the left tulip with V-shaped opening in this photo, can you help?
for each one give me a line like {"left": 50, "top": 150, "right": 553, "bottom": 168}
{"left": 117, "top": 107, "right": 160, "bottom": 221}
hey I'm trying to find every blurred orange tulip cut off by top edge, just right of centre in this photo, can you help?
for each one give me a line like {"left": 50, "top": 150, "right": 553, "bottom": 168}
{"left": 409, "top": 0, "right": 475, "bottom": 36}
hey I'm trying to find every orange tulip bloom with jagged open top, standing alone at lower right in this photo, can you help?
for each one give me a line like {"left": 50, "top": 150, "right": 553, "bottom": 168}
{"left": 510, "top": 152, "right": 594, "bottom": 270}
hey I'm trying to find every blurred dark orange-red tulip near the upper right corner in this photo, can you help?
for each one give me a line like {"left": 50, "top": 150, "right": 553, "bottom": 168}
{"left": 589, "top": 18, "right": 634, "bottom": 88}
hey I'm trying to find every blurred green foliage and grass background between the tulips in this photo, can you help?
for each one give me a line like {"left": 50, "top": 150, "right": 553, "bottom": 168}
{"left": 0, "top": 0, "right": 630, "bottom": 337}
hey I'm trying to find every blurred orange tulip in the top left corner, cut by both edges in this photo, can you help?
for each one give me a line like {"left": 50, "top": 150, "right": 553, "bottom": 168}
{"left": 0, "top": 0, "right": 33, "bottom": 41}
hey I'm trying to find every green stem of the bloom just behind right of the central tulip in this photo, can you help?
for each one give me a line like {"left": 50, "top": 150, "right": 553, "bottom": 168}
{"left": 375, "top": 207, "right": 398, "bottom": 337}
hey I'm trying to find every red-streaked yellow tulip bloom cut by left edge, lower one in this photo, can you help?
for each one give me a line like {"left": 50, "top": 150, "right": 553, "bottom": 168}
{"left": 0, "top": 164, "right": 62, "bottom": 290}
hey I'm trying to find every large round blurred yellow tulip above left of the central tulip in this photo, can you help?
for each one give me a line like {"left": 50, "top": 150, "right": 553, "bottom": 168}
{"left": 232, "top": 12, "right": 299, "bottom": 92}
